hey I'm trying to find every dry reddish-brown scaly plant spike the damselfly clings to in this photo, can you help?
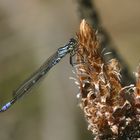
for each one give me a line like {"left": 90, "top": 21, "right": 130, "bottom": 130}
{"left": 75, "top": 20, "right": 140, "bottom": 140}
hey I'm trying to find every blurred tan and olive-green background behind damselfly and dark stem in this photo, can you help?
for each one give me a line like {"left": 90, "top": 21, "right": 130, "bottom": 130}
{"left": 0, "top": 0, "right": 140, "bottom": 140}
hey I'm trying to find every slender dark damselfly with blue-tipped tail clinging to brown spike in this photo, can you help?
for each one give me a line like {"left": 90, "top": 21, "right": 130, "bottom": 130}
{"left": 0, "top": 38, "right": 77, "bottom": 112}
